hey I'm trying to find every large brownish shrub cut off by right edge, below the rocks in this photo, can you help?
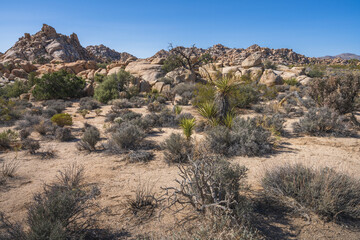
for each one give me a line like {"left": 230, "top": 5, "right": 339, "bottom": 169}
{"left": 308, "top": 74, "right": 360, "bottom": 114}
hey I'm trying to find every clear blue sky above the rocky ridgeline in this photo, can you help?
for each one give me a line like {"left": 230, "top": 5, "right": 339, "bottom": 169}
{"left": 0, "top": 0, "right": 360, "bottom": 57}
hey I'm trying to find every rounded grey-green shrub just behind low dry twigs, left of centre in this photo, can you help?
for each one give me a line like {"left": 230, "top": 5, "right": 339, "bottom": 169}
{"left": 107, "top": 122, "right": 145, "bottom": 153}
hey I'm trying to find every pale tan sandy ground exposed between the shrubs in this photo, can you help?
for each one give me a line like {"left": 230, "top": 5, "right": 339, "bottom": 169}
{"left": 0, "top": 103, "right": 360, "bottom": 239}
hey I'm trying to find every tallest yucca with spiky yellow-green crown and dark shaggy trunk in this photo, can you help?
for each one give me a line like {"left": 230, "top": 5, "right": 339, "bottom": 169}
{"left": 214, "top": 75, "right": 238, "bottom": 119}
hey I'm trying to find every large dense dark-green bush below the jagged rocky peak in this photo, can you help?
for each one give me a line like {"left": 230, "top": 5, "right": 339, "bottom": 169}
{"left": 32, "top": 70, "right": 85, "bottom": 100}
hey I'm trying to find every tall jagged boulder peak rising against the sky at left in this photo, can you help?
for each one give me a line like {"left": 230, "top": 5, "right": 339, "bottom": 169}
{"left": 1, "top": 24, "right": 94, "bottom": 63}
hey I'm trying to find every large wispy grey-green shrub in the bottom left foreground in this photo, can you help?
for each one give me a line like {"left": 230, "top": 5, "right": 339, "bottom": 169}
{"left": 0, "top": 166, "right": 100, "bottom": 239}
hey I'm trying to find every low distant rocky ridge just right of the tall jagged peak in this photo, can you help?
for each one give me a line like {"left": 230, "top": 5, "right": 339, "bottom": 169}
{"left": 86, "top": 44, "right": 136, "bottom": 62}
